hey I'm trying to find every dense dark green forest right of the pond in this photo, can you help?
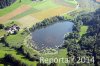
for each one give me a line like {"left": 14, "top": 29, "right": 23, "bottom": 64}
{"left": 63, "top": 9, "right": 100, "bottom": 66}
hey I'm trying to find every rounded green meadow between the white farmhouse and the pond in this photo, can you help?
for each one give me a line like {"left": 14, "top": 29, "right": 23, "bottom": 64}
{"left": 6, "top": 32, "right": 28, "bottom": 47}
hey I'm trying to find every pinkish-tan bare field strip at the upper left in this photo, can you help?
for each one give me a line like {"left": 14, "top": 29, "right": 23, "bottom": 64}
{"left": 0, "top": 5, "right": 31, "bottom": 23}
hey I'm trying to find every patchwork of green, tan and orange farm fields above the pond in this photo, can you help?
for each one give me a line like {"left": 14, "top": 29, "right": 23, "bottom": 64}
{"left": 0, "top": 0, "right": 77, "bottom": 28}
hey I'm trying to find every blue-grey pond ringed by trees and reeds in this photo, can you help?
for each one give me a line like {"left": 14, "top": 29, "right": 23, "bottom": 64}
{"left": 32, "top": 21, "right": 73, "bottom": 50}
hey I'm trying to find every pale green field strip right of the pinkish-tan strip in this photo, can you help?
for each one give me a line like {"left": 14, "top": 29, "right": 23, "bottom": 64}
{"left": 13, "top": 0, "right": 59, "bottom": 19}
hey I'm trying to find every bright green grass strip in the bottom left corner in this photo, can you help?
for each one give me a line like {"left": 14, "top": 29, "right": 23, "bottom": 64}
{"left": 0, "top": 43, "right": 37, "bottom": 66}
